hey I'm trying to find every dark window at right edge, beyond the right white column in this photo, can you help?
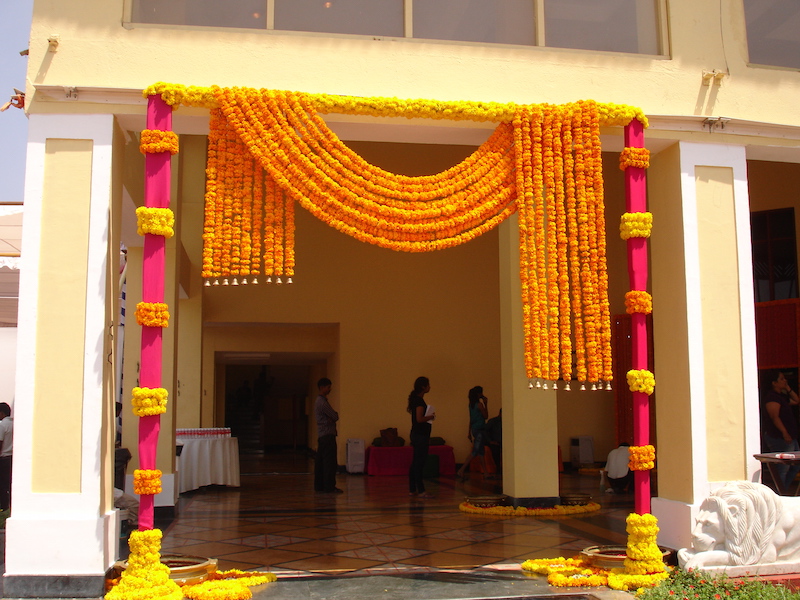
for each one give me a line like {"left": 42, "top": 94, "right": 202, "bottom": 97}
{"left": 750, "top": 208, "right": 798, "bottom": 302}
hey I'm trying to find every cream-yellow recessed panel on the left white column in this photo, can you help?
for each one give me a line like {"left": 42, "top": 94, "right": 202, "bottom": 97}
{"left": 31, "top": 139, "right": 92, "bottom": 493}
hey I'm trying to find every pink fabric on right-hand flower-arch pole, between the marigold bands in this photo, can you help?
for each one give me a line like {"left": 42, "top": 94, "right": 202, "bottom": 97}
{"left": 625, "top": 119, "right": 650, "bottom": 515}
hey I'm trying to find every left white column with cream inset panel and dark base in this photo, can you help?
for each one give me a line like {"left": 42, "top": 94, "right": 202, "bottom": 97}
{"left": 4, "top": 114, "right": 118, "bottom": 597}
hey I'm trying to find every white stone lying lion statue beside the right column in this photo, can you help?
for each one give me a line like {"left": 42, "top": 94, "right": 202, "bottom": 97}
{"left": 678, "top": 481, "right": 800, "bottom": 569}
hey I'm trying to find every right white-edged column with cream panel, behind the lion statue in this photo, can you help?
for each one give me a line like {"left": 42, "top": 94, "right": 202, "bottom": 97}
{"left": 650, "top": 142, "right": 760, "bottom": 548}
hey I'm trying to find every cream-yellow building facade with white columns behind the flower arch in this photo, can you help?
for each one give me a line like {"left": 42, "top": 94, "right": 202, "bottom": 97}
{"left": 5, "top": 0, "right": 800, "bottom": 597}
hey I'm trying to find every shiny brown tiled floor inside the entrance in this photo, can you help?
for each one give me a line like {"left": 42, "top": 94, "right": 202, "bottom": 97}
{"left": 152, "top": 455, "right": 633, "bottom": 576}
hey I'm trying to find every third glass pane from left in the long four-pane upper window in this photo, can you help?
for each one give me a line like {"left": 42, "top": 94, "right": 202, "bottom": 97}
{"left": 414, "top": 0, "right": 536, "bottom": 46}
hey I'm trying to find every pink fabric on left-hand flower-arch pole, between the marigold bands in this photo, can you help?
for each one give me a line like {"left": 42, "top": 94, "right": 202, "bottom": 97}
{"left": 139, "top": 96, "right": 172, "bottom": 531}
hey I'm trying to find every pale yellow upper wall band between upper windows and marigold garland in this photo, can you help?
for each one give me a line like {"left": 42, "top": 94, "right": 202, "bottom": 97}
{"left": 28, "top": 0, "right": 800, "bottom": 124}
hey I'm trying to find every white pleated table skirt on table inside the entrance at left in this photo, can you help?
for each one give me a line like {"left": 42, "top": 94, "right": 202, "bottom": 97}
{"left": 178, "top": 438, "right": 240, "bottom": 492}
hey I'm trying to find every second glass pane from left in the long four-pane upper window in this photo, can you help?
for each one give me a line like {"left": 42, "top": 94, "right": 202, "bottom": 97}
{"left": 275, "top": 0, "right": 404, "bottom": 37}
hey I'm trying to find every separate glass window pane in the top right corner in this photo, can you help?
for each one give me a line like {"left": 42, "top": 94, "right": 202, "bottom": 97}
{"left": 744, "top": 0, "right": 800, "bottom": 68}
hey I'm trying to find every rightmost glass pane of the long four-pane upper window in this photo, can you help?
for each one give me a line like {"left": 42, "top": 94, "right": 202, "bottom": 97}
{"left": 544, "top": 0, "right": 659, "bottom": 54}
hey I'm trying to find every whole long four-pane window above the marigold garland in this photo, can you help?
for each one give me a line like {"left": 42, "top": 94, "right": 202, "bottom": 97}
{"left": 128, "top": 0, "right": 664, "bottom": 54}
